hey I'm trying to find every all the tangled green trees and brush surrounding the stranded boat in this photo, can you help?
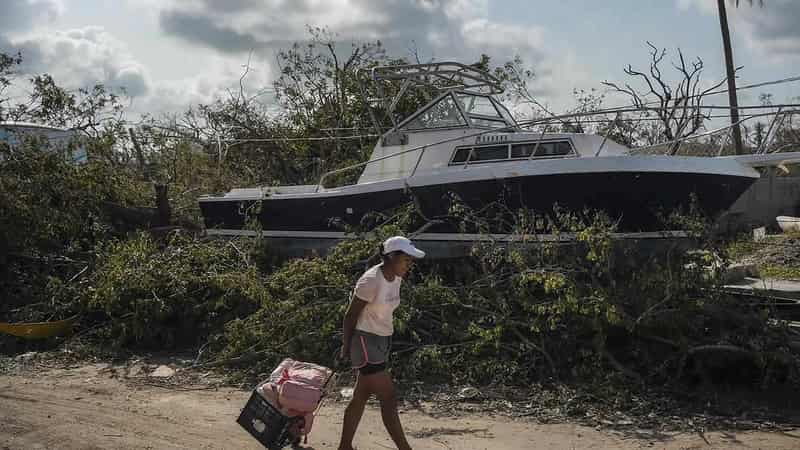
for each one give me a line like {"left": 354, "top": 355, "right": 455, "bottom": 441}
{"left": 0, "top": 30, "right": 800, "bottom": 400}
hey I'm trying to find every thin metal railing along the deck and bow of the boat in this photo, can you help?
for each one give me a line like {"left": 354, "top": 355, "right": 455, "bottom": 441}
{"left": 315, "top": 104, "right": 800, "bottom": 192}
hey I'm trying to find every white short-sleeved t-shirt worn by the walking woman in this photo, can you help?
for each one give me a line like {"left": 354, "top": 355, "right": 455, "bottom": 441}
{"left": 353, "top": 264, "right": 403, "bottom": 336}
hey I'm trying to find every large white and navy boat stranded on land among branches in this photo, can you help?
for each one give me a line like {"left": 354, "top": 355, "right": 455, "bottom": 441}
{"left": 199, "top": 62, "right": 800, "bottom": 246}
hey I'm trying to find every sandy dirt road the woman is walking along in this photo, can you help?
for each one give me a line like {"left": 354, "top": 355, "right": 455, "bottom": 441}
{"left": 0, "top": 364, "right": 800, "bottom": 450}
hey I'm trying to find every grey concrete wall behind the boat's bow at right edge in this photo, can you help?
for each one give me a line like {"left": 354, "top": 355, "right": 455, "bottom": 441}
{"left": 719, "top": 166, "right": 800, "bottom": 232}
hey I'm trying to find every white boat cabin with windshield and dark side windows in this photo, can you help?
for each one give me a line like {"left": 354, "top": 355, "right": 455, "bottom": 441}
{"left": 358, "top": 91, "right": 628, "bottom": 184}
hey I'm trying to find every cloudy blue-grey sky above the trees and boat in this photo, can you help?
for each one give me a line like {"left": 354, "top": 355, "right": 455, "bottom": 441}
{"left": 0, "top": 0, "right": 800, "bottom": 117}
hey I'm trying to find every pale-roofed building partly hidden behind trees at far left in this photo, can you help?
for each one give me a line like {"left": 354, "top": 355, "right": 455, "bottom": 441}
{"left": 0, "top": 122, "right": 88, "bottom": 164}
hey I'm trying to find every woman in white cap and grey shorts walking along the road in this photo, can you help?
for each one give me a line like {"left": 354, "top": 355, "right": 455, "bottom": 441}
{"left": 339, "top": 236, "right": 425, "bottom": 450}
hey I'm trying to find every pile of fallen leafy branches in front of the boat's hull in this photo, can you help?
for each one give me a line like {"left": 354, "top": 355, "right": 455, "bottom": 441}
{"left": 205, "top": 204, "right": 797, "bottom": 385}
